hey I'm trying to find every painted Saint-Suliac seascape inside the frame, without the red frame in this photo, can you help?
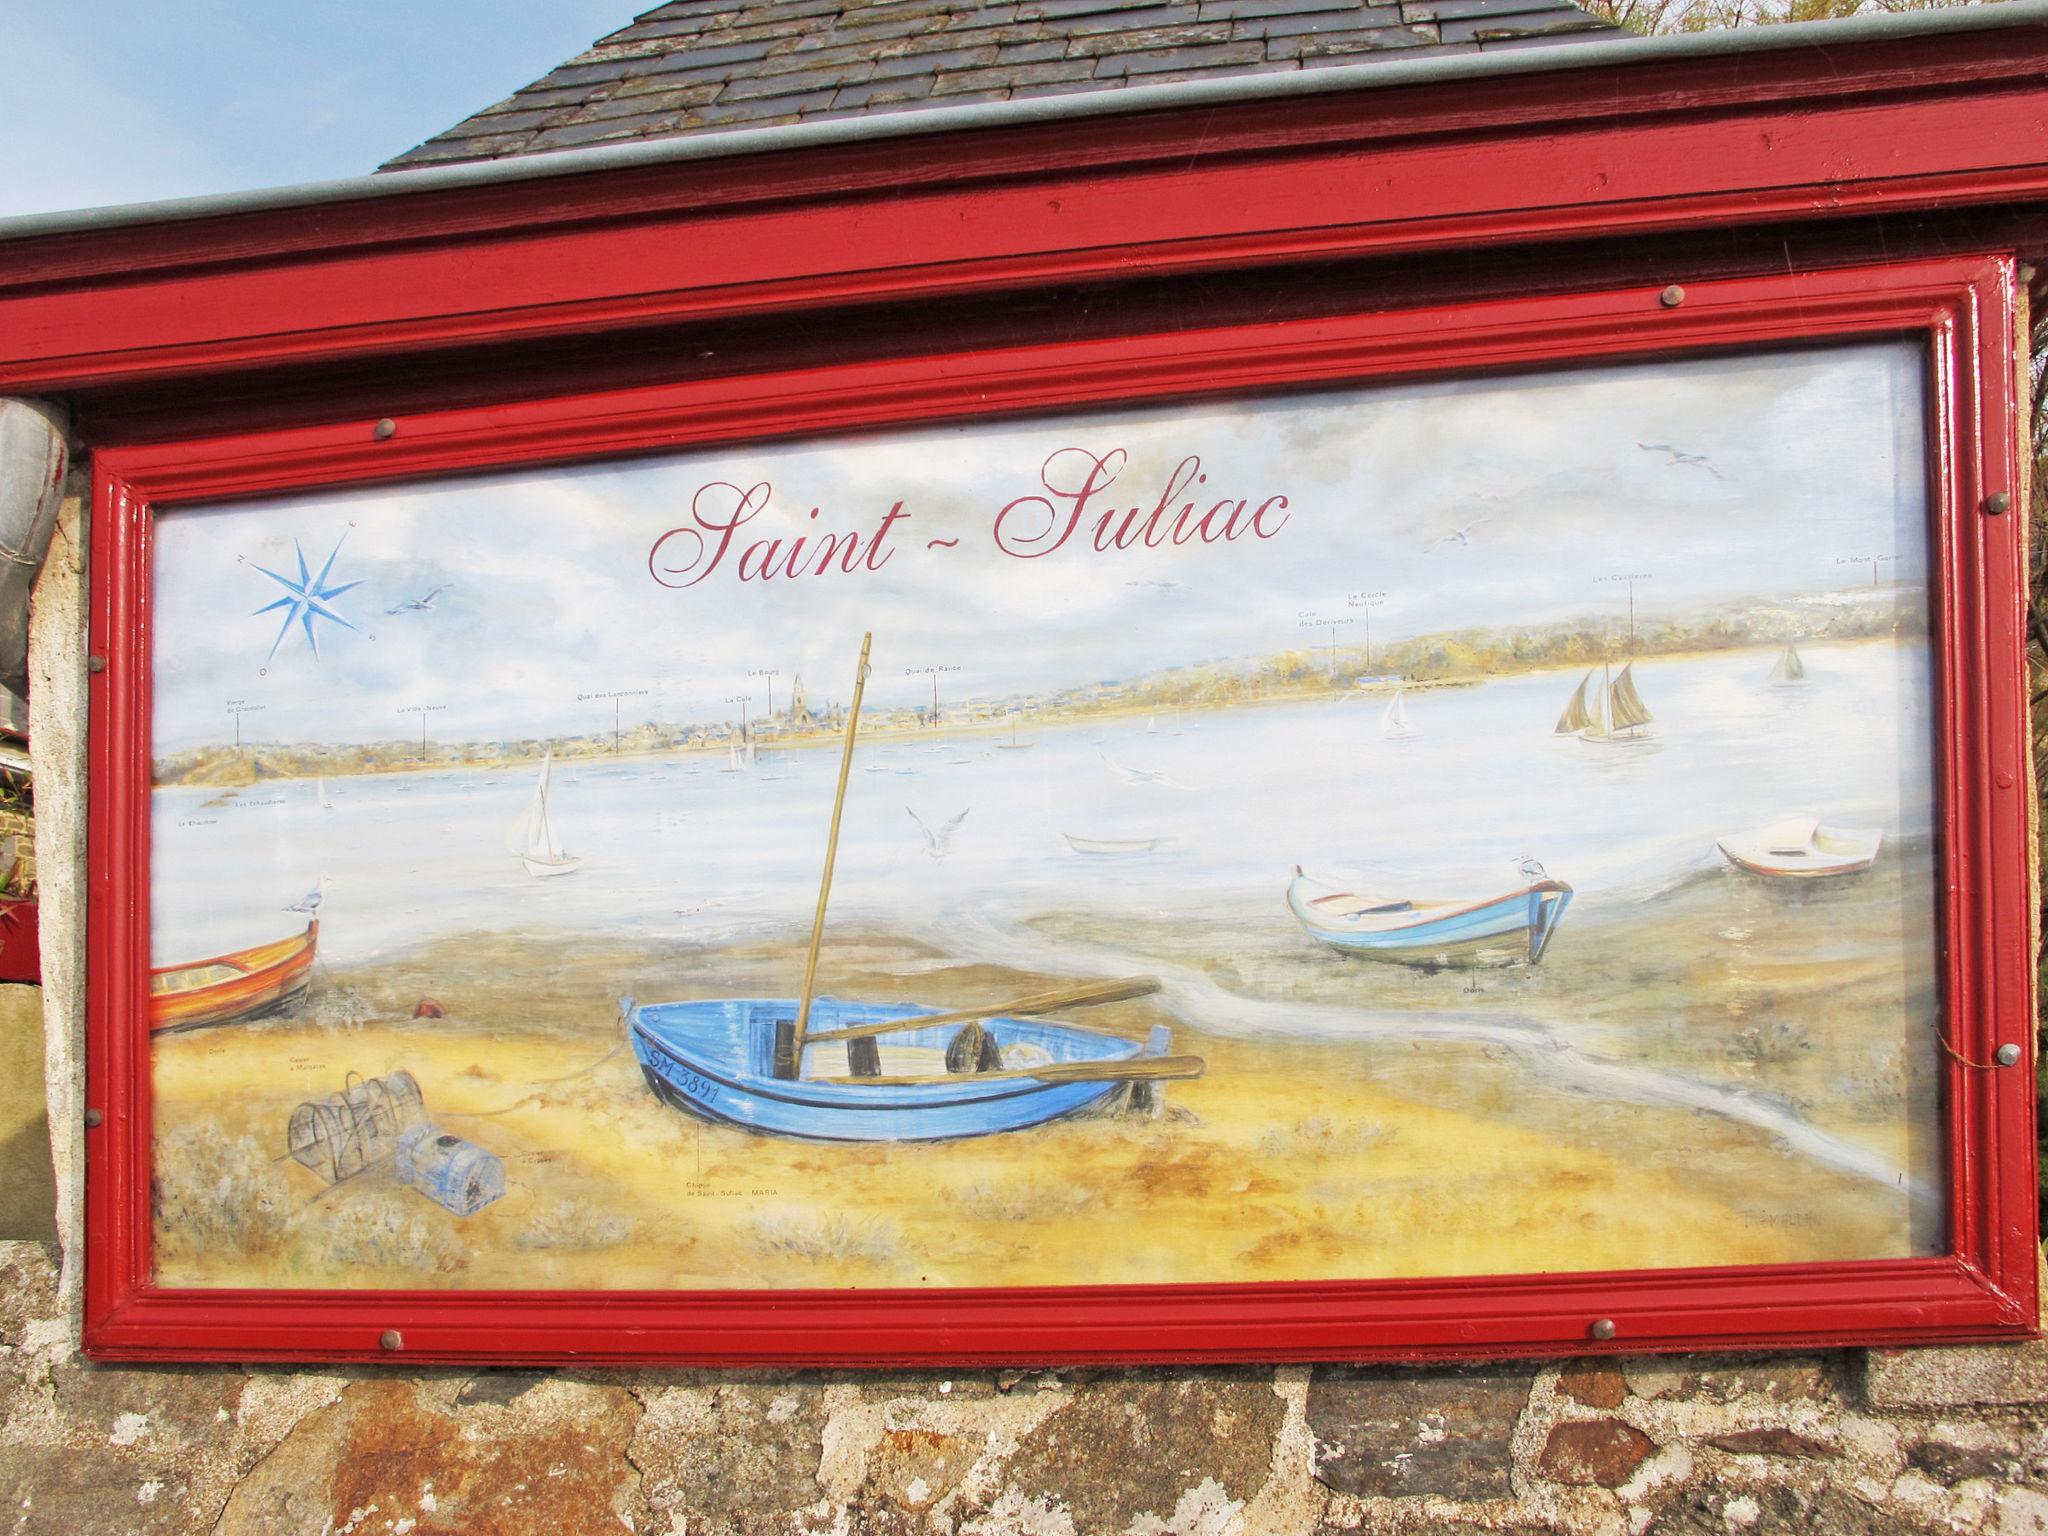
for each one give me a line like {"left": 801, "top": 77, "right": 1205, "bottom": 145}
{"left": 150, "top": 344, "right": 1946, "bottom": 1288}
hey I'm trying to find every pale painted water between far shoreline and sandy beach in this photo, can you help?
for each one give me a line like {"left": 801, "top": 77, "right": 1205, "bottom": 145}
{"left": 152, "top": 643, "right": 1933, "bottom": 965}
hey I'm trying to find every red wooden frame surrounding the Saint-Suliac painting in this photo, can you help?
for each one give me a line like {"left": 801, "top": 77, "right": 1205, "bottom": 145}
{"left": 84, "top": 254, "right": 2038, "bottom": 1364}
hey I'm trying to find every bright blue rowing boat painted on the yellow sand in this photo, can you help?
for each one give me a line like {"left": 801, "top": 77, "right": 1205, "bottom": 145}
{"left": 618, "top": 997, "right": 1202, "bottom": 1141}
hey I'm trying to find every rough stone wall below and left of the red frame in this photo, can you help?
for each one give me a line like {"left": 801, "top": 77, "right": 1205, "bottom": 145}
{"left": 0, "top": 481, "right": 2048, "bottom": 1536}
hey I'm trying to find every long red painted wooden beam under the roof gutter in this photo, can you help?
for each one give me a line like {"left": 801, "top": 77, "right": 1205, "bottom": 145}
{"left": 12, "top": 25, "right": 2048, "bottom": 391}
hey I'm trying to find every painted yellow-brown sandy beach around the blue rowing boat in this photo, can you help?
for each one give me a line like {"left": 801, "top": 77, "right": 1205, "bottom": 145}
{"left": 156, "top": 835, "right": 1939, "bottom": 1288}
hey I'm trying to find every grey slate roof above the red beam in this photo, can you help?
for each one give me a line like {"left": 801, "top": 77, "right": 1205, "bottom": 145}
{"left": 383, "top": 0, "right": 1622, "bottom": 170}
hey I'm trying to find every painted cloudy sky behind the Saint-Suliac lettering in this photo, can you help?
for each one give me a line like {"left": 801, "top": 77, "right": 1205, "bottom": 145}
{"left": 156, "top": 342, "right": 1925, "bottom": 752}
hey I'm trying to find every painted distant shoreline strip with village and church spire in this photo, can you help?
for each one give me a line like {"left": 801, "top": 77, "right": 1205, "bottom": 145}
{"left": 154, "top": 584, "right": 1925, "bottom": 786}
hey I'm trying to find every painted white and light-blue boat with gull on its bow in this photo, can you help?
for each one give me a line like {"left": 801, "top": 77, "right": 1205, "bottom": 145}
{"left": 1286, "top": 860, "right": 1571, "bottom": 971}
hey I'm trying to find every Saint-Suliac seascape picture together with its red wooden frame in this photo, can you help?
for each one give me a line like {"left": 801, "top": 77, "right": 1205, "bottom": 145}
{"left": 86, "top": 258, "right": 2036, "bottom": 1364}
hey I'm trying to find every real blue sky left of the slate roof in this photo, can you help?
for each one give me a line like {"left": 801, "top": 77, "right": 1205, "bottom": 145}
{"left": 0, "top": 0, "right": 638, "bottom": 217}
